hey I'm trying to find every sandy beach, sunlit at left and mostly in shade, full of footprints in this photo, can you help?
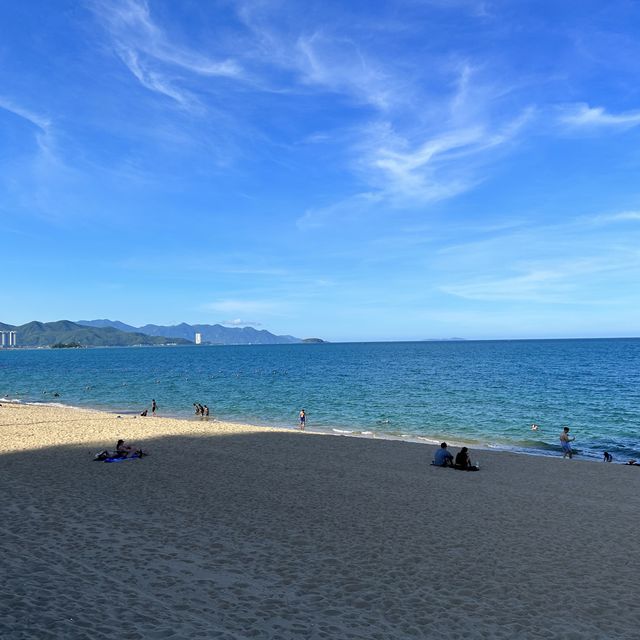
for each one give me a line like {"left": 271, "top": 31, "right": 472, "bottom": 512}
{"left": 0, "top": 404, "right": 640, "bottom": 640}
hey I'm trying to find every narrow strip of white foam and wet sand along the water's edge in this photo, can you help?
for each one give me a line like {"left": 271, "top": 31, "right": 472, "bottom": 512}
{"left": 0, "top": 398, "right": 625, "bottom": 464}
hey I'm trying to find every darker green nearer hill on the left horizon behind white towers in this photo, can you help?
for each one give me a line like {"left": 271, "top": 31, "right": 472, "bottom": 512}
{"left": 0, "top": 320, "right": 190, "bottom": 347}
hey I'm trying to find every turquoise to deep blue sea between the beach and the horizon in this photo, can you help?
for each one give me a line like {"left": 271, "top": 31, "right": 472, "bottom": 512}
{"left": 0, "top": 339, "right": 640, "bottom": 460}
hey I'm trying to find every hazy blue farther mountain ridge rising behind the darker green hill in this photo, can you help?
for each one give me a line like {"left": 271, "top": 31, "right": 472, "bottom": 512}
{"left": 78, "top": 320, "right": 302, "bottom": 344}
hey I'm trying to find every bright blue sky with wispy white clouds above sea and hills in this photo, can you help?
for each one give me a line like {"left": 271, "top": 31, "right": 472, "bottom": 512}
{"left": 0, "top": 0, "right": 640, "bottom": 340}
